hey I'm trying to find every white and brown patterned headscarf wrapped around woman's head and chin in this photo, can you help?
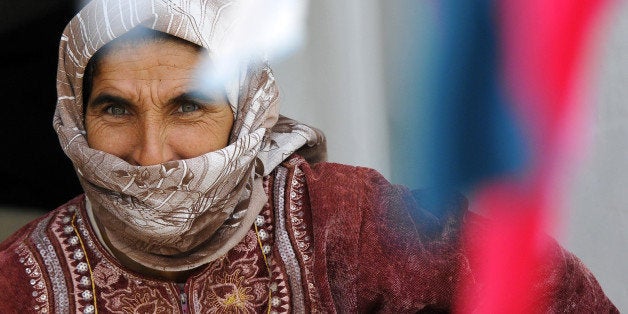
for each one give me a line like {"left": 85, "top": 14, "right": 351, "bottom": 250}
{"left": 53, "top": 0, "right": 325, "bottom": 271}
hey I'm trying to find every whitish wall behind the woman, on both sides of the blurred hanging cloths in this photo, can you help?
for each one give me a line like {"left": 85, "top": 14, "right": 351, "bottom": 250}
{"left": 274, "top": 0, "right": 628, "bottom": 312}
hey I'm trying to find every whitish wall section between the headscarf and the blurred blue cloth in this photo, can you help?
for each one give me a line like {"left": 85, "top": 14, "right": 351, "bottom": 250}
{"left": 274, "top": 0, "right": 390, "bottom": 174}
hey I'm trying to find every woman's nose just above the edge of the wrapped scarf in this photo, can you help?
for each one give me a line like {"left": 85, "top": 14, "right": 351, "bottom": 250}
{"left": 131, "top": 125, "right": 176, "bottom": 166}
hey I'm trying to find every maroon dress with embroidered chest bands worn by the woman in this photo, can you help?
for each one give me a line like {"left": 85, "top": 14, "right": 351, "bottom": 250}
{"left": 0, "top": 157, "right": 617, "bottom": 313}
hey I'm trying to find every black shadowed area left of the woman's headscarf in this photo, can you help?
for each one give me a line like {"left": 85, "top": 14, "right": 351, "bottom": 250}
{"left": 0, "top": 0, "right": 81, "bottom": 210}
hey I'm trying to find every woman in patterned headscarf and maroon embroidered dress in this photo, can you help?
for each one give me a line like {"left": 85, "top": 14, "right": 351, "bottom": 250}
{"left": 0, "top": 0, "right": 615, "bottom": 313}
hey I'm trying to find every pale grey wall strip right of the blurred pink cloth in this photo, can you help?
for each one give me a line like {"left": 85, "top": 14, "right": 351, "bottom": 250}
{"left": 563, "top": 1, "right": 628, "bottom": 312}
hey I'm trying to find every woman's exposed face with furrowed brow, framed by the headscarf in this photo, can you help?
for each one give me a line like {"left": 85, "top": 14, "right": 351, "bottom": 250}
{"left": 85, "top": 40, "right": 233, "bottom": 166}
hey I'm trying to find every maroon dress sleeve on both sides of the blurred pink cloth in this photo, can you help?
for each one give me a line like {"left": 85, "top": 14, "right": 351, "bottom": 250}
{"left": 305, "top": 164, "right": 618, "bottom": 313}
